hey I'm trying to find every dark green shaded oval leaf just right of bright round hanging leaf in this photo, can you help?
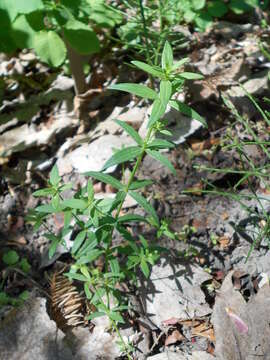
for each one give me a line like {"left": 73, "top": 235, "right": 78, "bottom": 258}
{"left": 63, "top": 19, "right": 100, "bottom": 55}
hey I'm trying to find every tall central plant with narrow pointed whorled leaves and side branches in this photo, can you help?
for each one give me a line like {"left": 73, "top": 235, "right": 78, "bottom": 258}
{"left": 30, "top": 42, "right": 203, "bottom": 358}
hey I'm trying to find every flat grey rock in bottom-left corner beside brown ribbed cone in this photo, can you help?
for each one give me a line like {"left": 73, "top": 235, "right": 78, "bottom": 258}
{"left": 0, "top": 298, "right": 74, "bottom": 360}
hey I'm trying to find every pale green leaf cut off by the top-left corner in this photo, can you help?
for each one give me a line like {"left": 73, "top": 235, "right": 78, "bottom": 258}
{"left": 0, "top": 0, "right": 44, "bottom": 21}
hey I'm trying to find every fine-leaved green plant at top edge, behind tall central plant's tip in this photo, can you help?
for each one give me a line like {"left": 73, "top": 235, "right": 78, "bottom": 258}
{"left": 118, "top": 0, "right": 187, "bottom": 66}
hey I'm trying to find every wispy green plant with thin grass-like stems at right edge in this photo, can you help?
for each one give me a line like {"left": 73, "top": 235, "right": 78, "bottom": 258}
{"left": 193, "top": 89, "right": 270, "bottom": 261}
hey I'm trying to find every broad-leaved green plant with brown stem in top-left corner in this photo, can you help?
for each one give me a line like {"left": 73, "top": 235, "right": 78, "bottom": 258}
{"left": 0, "top": 0, "right": 119, "bottom": 94}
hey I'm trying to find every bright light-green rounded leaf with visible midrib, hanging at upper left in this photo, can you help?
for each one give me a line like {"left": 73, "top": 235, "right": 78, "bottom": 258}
{"left": 34, "top": 30, "right": 66, "bottom": 67}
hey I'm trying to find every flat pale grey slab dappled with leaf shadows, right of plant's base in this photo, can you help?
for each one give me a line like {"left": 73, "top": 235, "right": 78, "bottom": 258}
{"left": 139, "top": 258, "right": 211, "bottom": 328}
